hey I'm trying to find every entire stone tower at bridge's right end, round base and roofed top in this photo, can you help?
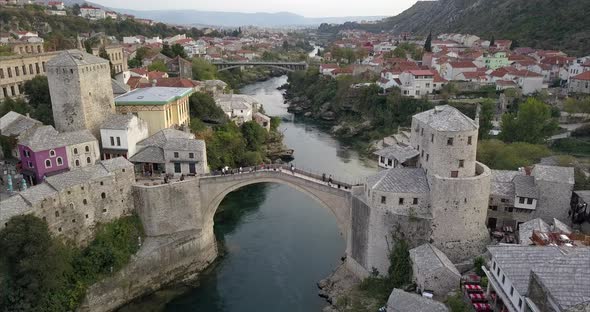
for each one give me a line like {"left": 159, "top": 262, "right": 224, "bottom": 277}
{"left": 410, "top": 105, "right": 491, "bottom": 261}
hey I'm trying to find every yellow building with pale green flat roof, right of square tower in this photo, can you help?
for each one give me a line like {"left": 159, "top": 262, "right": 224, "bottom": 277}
{"left": 115, "top": 87, "right": 193, "bottom": 135}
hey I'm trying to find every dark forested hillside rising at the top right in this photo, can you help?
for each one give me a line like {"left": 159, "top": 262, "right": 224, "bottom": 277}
{"left": 320, "top": 0, "right": 590, "bottom": 55}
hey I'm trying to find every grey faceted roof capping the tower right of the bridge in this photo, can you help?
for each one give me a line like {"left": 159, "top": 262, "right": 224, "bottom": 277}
{"left": 414, "top": 105, "right": 479, "bottom": 131}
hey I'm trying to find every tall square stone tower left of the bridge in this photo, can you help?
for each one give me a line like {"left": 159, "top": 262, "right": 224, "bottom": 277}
{"left": 47, "top": 50, "right": 115, "bottom": 138}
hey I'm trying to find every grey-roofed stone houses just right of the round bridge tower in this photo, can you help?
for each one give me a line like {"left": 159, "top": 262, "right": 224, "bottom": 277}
{"left": 487, "top": 165, "right": 574, "bottom": 229}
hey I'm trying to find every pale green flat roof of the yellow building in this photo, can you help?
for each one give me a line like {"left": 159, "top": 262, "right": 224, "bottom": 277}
{"left": 115, "top": 87, "right": 193, "bottom": 106}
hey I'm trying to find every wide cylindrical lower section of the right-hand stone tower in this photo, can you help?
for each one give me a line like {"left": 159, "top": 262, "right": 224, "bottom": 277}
{"left": 431, "top": 163, "right": 491, "bottom": 263}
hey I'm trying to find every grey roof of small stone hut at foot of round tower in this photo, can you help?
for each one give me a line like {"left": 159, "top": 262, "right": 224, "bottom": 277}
{"left": 410, "top": 244, "right": 461, "bottom": 278}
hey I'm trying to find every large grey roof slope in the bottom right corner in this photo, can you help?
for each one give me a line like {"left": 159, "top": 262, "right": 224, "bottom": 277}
{"left": 533, "top": 247, "right": 590, "bottom": 310}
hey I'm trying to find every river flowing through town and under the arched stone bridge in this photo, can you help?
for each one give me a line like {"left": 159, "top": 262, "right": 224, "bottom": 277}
{"left": 125, "top": 76, "right": 377, "bottom": 312}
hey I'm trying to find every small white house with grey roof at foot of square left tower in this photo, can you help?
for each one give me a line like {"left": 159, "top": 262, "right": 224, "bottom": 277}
{"left": 100, "top": 114, "right": 148, "bottom": 159}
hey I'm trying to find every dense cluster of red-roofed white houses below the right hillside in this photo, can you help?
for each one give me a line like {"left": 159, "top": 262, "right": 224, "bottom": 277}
{"left": 320, "top": 30, "right": 590, "bottom": 98}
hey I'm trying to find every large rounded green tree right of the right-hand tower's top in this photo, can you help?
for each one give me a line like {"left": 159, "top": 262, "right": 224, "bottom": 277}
{"left": 500, "top": 98, "right": 558, "bottom": 144}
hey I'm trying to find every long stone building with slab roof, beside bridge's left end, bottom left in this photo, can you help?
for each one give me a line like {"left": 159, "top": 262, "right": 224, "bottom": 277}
{"left": 0, "top": 157, "right": 135, "bottom": 244}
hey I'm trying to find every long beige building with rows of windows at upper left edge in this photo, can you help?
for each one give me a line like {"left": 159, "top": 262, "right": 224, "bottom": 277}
{"left": 0, "top": 52, "right": 58, "bottom": 100}
